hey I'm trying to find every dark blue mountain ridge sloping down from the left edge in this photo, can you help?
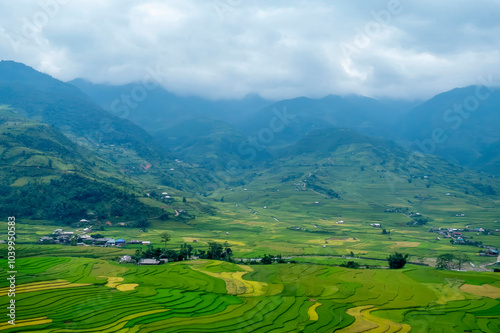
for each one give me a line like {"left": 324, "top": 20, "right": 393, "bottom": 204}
{"left": 0, "top": 61, "right": 164, "bottom": 159}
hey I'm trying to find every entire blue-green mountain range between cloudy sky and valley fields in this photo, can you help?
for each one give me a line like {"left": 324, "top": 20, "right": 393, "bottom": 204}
{"left": 0, "top": 61, "right": 500, "bottom": 224}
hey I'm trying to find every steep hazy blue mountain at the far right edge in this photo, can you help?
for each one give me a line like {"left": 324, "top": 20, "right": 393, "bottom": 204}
{"left": 395, "top": 86, "right": 500, "bottom": 174}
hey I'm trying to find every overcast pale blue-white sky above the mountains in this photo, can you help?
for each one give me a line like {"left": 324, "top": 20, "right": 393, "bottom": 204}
{"left": 0, "top": 0, "right": 500, "bottom": 100}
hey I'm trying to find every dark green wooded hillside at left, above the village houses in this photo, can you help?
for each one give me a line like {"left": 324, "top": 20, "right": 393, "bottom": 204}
{"left": 0, "top": 174, "right": 164, "bottom": 225}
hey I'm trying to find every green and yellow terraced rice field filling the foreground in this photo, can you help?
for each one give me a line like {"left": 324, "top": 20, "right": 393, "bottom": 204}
{"left": 0, "top": 257, "right": 500, "bottom": 333}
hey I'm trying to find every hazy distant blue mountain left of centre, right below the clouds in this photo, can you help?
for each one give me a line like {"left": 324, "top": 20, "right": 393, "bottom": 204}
{"left": 68, "top": 79, "right": 272, "bottom": 134}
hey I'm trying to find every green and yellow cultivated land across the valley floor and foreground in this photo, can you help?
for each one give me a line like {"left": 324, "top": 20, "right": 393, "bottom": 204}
{"left": 0, "top": 169, "right": 500, "bottom": 332}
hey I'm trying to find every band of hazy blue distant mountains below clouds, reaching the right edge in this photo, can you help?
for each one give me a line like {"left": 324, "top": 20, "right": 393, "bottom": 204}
{"left": 70, "top": 63, "right": 500, "bottom": 174}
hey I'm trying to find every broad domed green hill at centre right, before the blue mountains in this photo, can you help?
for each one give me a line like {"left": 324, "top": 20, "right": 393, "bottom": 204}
{"left": 237, "top": 128, "right": 500, "bottom": 209}
